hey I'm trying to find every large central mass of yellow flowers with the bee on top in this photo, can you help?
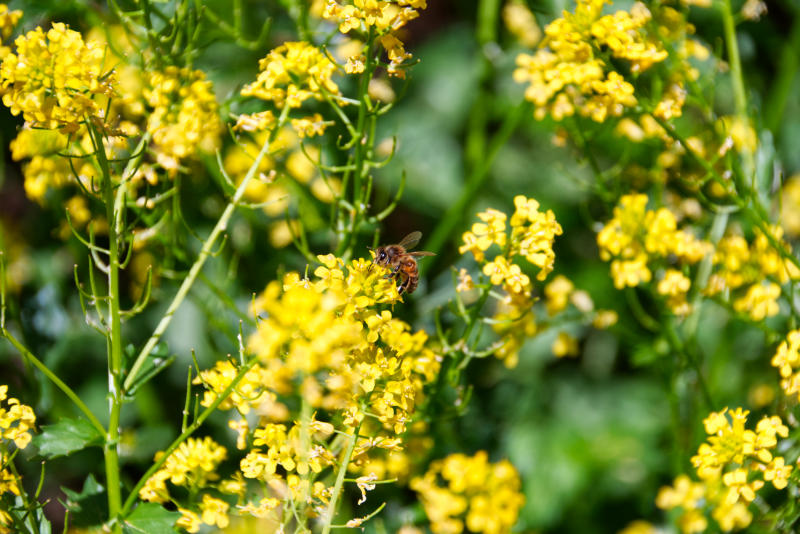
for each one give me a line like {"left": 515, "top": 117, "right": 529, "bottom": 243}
{"left": 180, "top": 255, "right": 440, "bottom": 524}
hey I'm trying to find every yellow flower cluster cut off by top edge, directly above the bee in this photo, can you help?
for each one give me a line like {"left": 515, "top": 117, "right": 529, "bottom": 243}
{"left": 322, "top": 0, "right": 428, "bottom": 78}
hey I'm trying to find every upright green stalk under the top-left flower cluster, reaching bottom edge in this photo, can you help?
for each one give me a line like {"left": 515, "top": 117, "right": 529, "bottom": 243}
{"left": 87, "top": 121, "right": 124, "bottom": 534}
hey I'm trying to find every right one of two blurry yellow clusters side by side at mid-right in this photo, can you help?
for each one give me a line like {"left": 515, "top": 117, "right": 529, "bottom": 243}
{"left": 707, "top": 227, "right": 800, "bottom": 321}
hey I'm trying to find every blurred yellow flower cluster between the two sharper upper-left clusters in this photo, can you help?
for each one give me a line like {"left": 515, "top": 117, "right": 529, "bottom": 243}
{"left": 143, "top": 66, "right": 222, "bottom": 175}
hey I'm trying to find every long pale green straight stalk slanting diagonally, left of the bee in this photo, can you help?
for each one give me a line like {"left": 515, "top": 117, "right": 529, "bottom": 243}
{"left": 124, "top": 106, "right": 289, "bottom": 391}
